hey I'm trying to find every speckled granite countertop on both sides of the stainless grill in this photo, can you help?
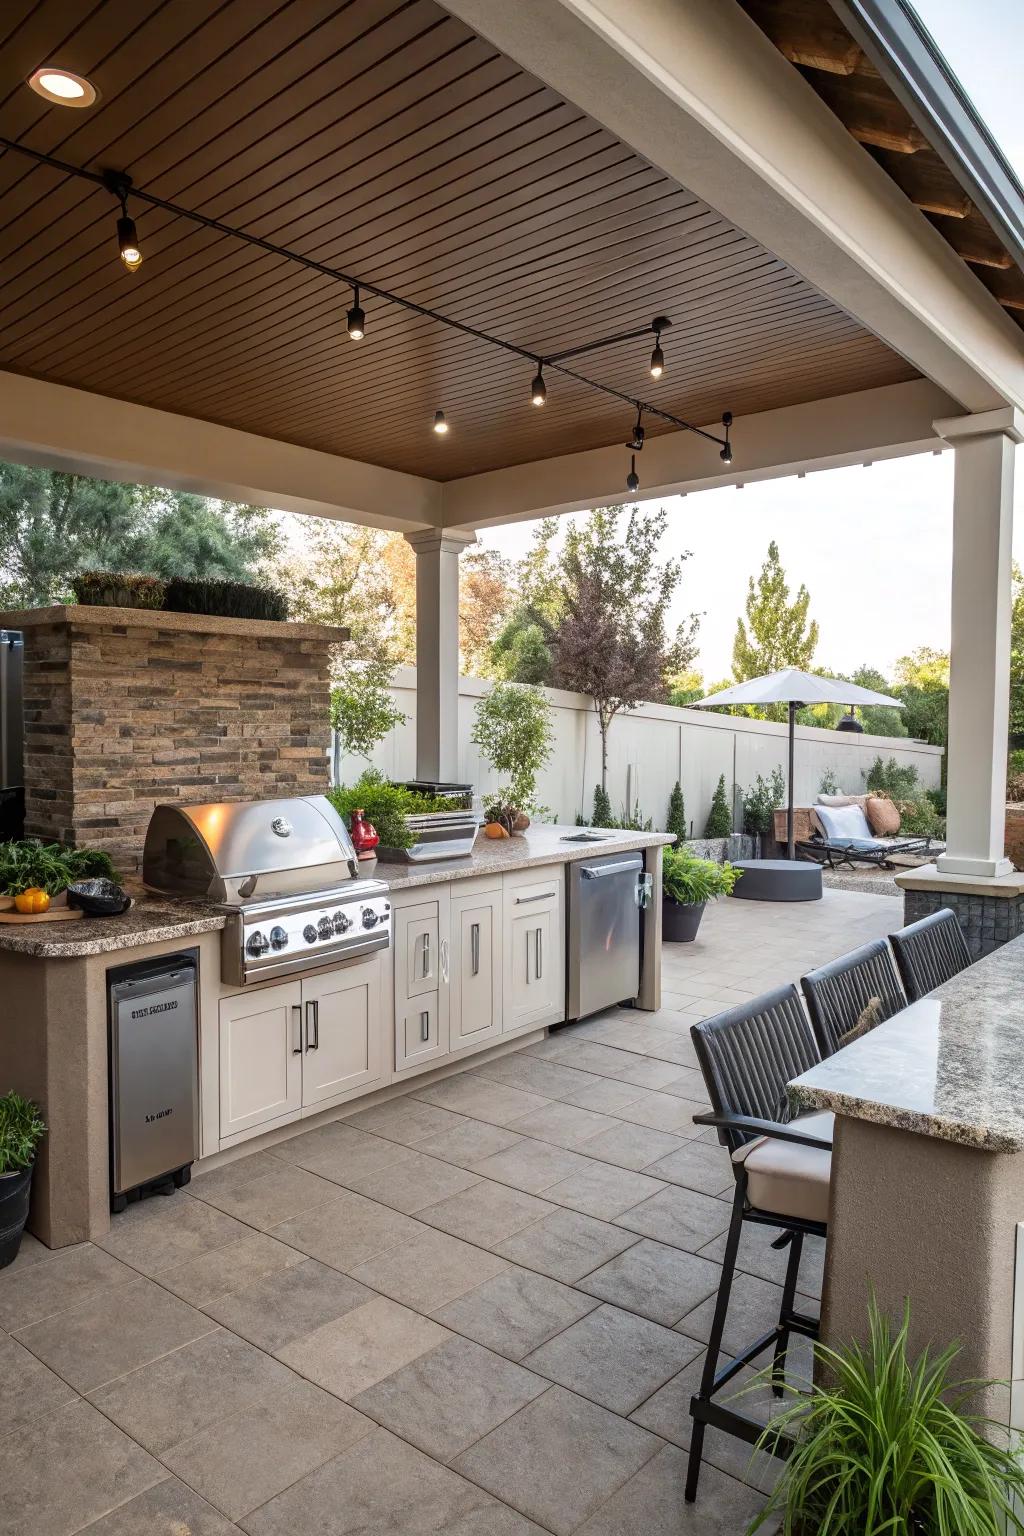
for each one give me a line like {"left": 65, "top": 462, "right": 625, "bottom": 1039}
{"left": 0, "top": 826, "right": 674, "bottom": 960}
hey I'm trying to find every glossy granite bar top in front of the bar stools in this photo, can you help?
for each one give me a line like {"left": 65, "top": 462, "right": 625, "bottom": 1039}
{"left": 789, "top": 938, "right": 1024, "bottom": 1152}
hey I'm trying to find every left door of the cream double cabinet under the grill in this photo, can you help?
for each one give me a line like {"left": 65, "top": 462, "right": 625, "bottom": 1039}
{"left": 220, "top": 982, "right": 302, "bottom": 1141}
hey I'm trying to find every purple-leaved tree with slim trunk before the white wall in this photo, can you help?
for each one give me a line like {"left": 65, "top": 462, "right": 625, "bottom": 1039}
{"left": 551, "top": 507, "right": 699, "bottom": 790}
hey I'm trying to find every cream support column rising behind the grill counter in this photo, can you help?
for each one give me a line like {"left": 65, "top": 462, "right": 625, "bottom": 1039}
{"left": 405, "top": 528, "right": 476, "bottom": 783}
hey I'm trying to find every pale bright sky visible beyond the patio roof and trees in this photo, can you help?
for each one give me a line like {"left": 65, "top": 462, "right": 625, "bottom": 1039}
{"left": 481, "top": 0, "right": 1024, "bottom": 682}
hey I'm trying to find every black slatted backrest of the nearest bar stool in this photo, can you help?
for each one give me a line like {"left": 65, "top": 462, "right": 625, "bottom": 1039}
{"left": 689, "top": 982, "right": 821, "bottom": 1152}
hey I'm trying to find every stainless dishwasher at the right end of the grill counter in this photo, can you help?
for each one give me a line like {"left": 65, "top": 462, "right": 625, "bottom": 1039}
{"left": 565, "top": 852, "right": 649, "bottom": 1018}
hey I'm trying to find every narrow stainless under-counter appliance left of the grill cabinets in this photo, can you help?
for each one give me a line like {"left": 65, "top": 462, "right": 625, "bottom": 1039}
{"left": 107, "top": 954, "right": 200, "bottom": 1210}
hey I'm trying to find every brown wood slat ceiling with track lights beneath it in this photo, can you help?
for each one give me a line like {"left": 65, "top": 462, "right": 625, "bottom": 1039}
{"left": 0, "top": 0, "right": 915, "bottom": 479}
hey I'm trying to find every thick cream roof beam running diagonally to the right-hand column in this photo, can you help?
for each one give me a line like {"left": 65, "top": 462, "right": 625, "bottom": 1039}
{"left": 445, "top": 0, "right": 1024, "bottom": 412}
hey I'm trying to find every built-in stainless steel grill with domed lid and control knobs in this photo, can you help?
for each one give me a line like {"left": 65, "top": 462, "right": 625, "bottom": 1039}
{"left": 143, "top": 796, "right": 391, "bottom": 986}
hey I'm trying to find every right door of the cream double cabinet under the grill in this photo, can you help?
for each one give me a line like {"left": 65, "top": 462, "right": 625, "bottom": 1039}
{"left": 302, "top": 951, "right": 387, "bottom": 1107}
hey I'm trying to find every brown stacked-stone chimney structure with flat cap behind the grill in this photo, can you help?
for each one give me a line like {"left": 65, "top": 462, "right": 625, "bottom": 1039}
{"left": 0, "top": 607, "right": 348, "bottom": 872}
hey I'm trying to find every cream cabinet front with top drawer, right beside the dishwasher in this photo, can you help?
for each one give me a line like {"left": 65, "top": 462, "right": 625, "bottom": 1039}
{"left": 502, "top": 880, "right": 565, "bottom": 1032}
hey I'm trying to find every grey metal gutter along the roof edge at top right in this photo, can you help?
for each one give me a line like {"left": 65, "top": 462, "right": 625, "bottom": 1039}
{"left": 829, "top": 0, "right": 1024, "bottom": 272}
